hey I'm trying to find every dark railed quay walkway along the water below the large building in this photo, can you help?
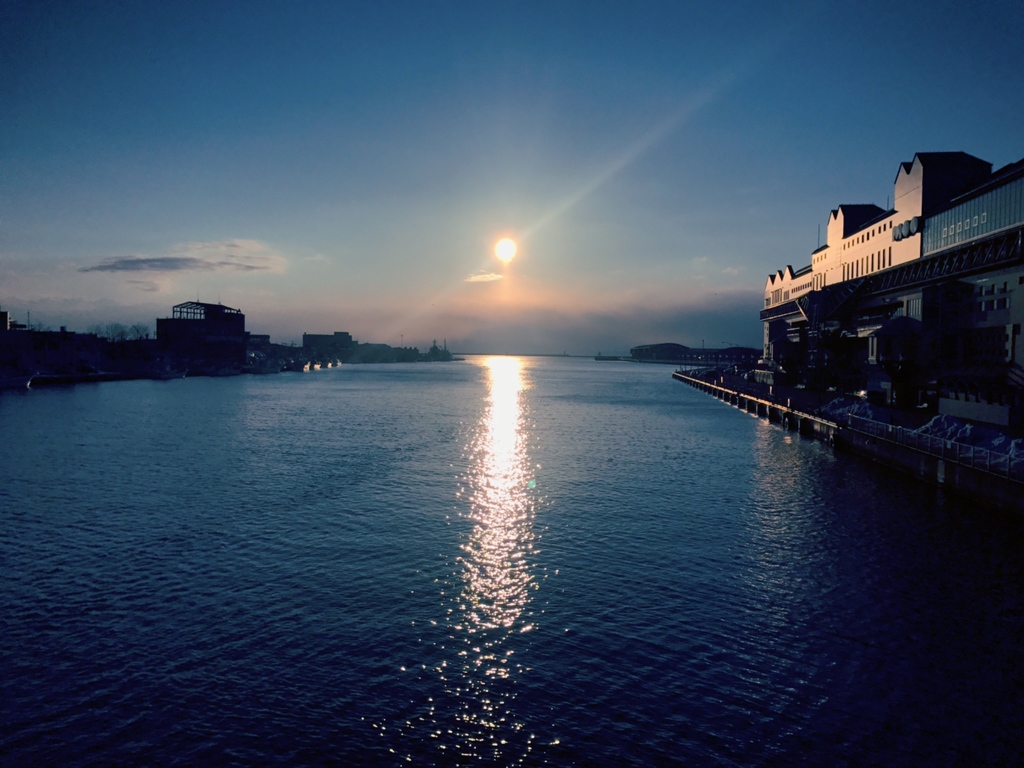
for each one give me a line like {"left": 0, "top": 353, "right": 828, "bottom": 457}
{"left": 672, "top": 371, "right": 1024, "bottom": 512}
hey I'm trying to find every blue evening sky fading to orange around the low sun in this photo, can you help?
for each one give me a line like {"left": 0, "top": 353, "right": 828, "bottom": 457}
{"left": 0, "top": 0, "right": 1024, "bottom": 354}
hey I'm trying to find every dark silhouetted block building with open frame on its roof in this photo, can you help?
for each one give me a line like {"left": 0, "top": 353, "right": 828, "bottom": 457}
{"left": 157, "top": 301, "right": 247, "bottom": 376}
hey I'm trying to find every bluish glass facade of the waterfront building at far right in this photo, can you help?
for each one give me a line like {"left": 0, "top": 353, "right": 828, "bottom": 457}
{"left": 922, "top": 177, "right": 1024, "bottom": 256}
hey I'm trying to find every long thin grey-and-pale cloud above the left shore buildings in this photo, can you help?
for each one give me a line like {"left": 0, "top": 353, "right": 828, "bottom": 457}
{"left": 79, "top": 240, "right": 287, "bottom": 272}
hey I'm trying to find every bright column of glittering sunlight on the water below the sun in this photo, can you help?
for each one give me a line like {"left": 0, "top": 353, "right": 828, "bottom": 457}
{"left": 440, "top": 357, "right": 536, "bottom": 763}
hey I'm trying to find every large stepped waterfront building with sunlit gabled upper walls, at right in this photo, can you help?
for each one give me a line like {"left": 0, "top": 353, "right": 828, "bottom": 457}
{"left": 761, "top": 152, "right": 1024, "bottom": 425}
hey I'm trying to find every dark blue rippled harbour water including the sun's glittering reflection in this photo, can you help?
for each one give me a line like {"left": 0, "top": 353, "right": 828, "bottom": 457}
{"left": 0, "top": 358, "right": 1024, "bottom": 766}
